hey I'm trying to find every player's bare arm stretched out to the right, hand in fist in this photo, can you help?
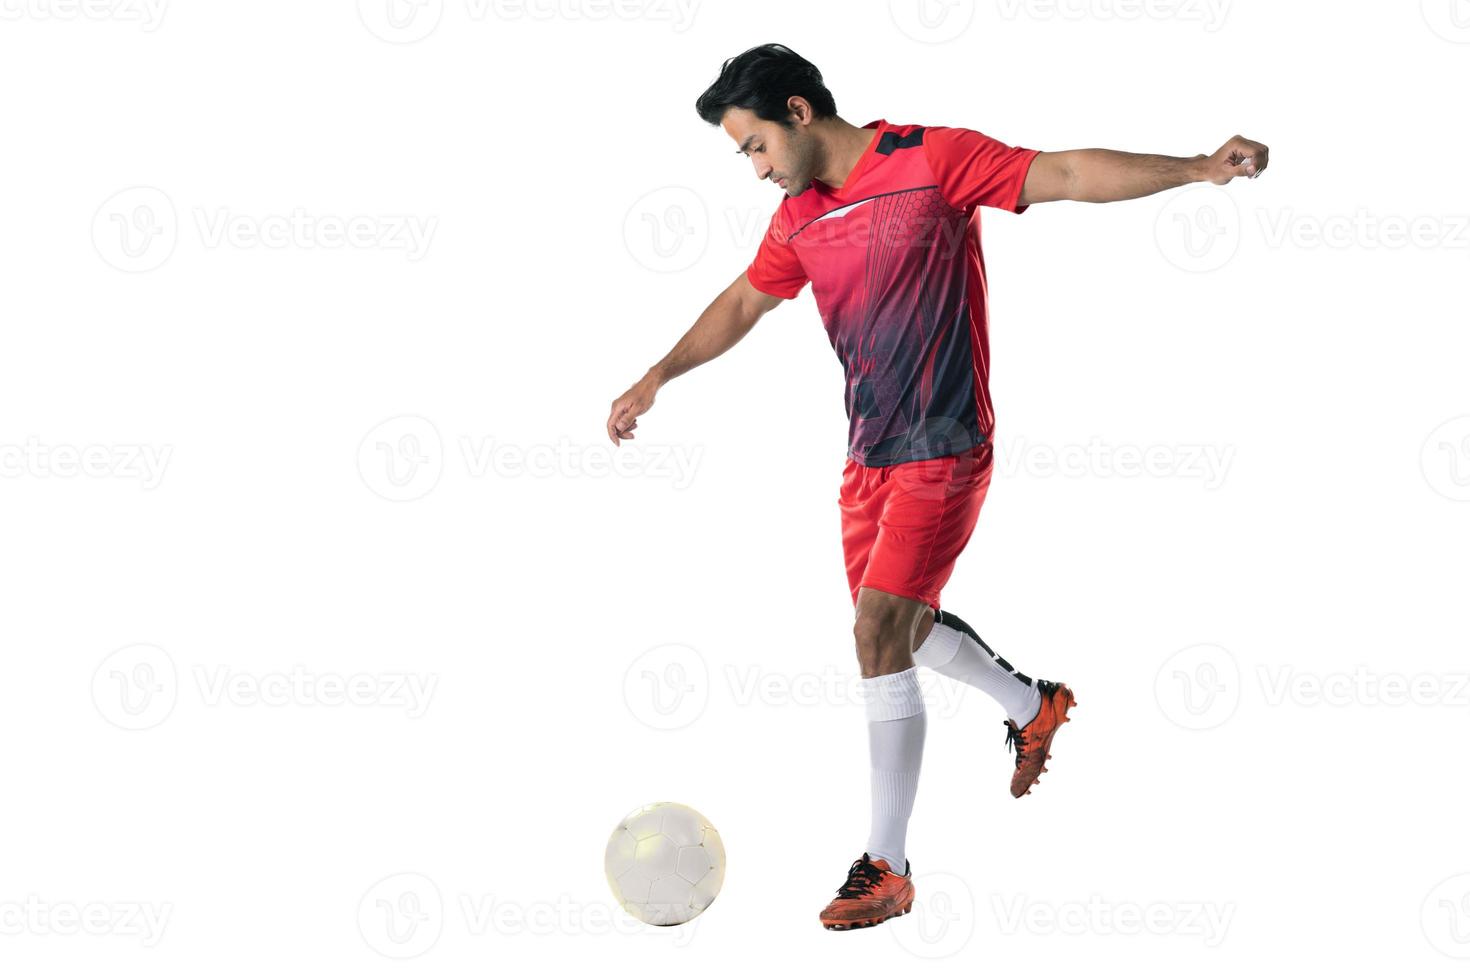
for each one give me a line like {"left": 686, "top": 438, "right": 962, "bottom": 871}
{"left": 1020, "top": 137, "right": 1270, "bottom": 204}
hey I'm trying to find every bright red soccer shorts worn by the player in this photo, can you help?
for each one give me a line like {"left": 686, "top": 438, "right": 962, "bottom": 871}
{"left": 838, "top": 439, "right": 995, "bottom": 608}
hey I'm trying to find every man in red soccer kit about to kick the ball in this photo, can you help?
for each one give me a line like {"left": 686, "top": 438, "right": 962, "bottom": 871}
{"left": 607, "top": 44, "right": 1267, "bottom": 929}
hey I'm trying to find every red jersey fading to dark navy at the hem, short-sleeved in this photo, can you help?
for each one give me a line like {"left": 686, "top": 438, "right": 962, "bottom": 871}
{"left": 745, "top": 119, "right": 1039, "bottom": 466}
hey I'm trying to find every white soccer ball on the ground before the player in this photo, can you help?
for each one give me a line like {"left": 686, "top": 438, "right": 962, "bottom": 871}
{"left": 606, "top": 802, "right": 725, "bottom": 926}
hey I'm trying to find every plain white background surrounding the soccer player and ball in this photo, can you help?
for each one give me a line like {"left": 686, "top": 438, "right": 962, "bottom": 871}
{"left": 0, "top": 0, "right": 1470, "bottom": 977}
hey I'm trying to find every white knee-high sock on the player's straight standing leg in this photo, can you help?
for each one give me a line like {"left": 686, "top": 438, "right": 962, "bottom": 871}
{"left": 858, "top": 667, "right": 925, "bottom": 874}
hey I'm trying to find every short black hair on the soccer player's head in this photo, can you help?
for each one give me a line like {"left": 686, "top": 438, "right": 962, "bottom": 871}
{"left": 694, "top": 44, "right": 836, "bottom": 129}
